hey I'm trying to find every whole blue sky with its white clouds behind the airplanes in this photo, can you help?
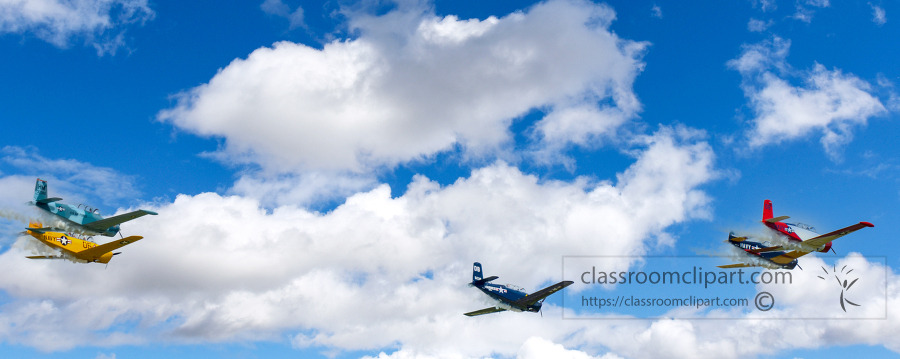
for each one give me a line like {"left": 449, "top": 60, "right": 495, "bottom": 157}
{"left": 0, "top": 0, "right": 900, "bottom": 358}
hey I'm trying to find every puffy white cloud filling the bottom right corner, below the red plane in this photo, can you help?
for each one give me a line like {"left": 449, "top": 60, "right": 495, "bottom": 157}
{"left": 566, "top": 254, "right": 900, "bottom": 358}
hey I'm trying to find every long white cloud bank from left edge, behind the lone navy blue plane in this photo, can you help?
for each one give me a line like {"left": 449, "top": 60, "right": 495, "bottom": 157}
{"left": 0, "top": 127, "right": 716, "bottom": 357}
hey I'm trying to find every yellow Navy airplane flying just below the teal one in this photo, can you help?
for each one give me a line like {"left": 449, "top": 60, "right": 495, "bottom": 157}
{"left": 27, "top": 222, "right": 144, "bottom": 264}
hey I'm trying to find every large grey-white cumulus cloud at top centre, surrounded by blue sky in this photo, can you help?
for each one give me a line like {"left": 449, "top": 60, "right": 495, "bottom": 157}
{"left": 158, "top": 0, "right": 647, "bottom": 172}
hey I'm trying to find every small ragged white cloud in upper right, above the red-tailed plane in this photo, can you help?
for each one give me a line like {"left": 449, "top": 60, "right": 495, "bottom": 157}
{"left": 728, "top": 37, "right": 887, "bottom": 160}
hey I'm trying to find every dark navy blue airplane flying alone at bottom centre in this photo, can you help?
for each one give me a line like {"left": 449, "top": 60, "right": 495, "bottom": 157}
{"left": 465, "top": 262, "right": 575, "bottom": 317}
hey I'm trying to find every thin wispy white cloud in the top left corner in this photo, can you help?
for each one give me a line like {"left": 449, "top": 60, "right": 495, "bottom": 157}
{"left": 0, "top": 0, "right": 155, "bottom": 56}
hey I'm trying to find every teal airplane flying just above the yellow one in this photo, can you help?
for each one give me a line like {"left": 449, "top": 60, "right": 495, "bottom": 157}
{"left": 29, "top": 178, "right": 156, "bottom": 237}
